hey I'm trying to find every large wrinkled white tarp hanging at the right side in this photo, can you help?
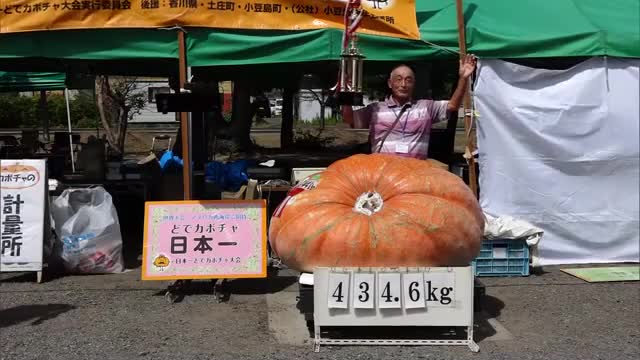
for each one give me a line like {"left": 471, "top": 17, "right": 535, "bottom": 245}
{"left": 474, "top": 58, "right": 640, "bottom": 265}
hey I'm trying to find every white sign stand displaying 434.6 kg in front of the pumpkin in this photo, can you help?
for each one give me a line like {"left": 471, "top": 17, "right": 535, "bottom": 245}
{"left": 313, "top": 266, "right": 480, "bottom": 352}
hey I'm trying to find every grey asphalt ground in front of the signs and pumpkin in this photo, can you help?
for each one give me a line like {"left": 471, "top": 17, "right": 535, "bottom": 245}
{"left": 0, "top": 267, "right": 640, "bottom": 360}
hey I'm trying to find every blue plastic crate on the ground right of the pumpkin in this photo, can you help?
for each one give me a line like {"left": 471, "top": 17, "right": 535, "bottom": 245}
{"left": 471, "top": 239, "right": 529, "bottom": 276}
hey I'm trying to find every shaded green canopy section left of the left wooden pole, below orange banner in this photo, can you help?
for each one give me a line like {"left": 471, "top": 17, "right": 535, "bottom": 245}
{"left": 0, "top": 29, "right": 178, "bottom": 76}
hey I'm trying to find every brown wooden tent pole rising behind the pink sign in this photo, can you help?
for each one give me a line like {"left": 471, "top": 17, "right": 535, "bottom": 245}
{"left": 178, "top": 30, "right": 191, "bottom": 200}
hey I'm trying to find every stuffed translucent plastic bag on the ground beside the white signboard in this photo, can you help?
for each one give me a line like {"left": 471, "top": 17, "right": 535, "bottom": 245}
{"left": 51, "top": 187, "right": 124, "bottom": 274}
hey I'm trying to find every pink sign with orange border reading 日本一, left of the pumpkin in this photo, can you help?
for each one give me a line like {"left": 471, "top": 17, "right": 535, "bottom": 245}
{"left": 142, "top": 200, "right": 267, "bottom": 280}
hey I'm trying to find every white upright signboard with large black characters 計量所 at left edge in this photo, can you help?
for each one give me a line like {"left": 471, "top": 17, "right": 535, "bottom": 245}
{"left": 0, "top": 160, "right": 47, "bottom": 272}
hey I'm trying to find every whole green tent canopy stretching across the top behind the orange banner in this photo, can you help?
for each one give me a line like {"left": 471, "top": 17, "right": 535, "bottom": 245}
{"left": 0, "top": 0, "right": 640, "bottom": 74}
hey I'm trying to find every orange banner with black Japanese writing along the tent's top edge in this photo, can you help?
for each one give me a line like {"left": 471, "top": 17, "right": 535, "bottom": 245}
{"left": 0, "top": 0, "right": 420, "bottom": 39}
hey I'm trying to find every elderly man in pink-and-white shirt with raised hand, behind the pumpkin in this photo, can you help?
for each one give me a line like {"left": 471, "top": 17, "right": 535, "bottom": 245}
{"left": 343, "top": 55, "right": 476, "bottom": 159}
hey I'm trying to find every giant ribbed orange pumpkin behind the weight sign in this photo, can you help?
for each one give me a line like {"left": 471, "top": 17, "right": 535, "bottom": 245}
{"left": 269, "top": 154, "right": 484, "bottom": 272}
